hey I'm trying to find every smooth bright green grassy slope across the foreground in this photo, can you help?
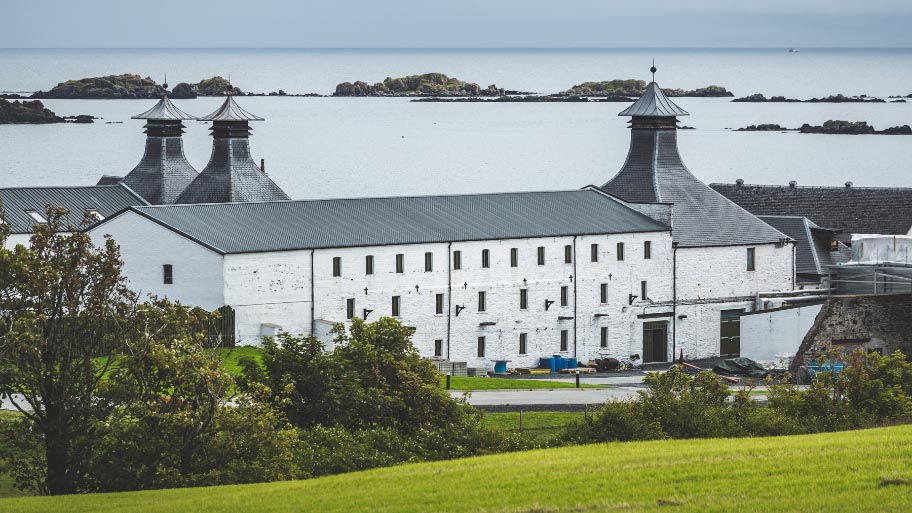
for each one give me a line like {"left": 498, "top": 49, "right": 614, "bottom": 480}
{"left": 7, "top": 426, "right": 912, "bottom": 513}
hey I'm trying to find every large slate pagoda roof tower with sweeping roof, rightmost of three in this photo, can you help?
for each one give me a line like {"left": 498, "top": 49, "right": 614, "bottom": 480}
{"left": 602, "top": 66, "right": 787, "bottom": 247}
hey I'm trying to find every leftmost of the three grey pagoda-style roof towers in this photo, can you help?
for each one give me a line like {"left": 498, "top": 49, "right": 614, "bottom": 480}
{"left": 122, "top": 92, "right": 199, "bottom": 205}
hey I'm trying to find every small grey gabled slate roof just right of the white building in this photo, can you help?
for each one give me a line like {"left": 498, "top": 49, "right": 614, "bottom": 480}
{"left": 758, "top": 216, "right": 848, "bottom": 276}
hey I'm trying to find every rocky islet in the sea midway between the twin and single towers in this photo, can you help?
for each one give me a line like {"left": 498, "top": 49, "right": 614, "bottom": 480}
{"left": 333, "top": 73, "right": 503, "bottom": 97}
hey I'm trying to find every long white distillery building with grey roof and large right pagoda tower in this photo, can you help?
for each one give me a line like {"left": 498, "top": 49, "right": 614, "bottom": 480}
{"left": 90, "top": 75, "right": 795, "bottom": 368}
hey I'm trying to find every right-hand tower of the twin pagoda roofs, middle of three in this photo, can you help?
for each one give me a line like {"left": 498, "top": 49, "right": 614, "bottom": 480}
{"left": 177, "top": 95, "right": 289, "bottom": 203}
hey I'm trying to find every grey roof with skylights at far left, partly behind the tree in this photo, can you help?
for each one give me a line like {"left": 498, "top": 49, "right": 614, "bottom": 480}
{"left": 0, "top": 185, "right": 147, "bottom": 233}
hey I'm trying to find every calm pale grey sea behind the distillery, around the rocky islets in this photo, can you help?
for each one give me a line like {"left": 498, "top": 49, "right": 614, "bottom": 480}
{"left": 0, "top": 48, "right": 912, "bottom": 199}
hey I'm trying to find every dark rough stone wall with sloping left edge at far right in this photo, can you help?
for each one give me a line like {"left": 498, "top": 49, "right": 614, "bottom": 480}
{"left": 792, "top": 294, "right": 912, "bottom": 371}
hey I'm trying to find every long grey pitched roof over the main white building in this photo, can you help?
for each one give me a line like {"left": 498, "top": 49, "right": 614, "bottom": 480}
{"left": 105, "top": 189, "right": 669, "bottom": 253}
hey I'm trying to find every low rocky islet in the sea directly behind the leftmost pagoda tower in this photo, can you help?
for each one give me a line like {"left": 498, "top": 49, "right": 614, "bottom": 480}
{"left": 31, "top": 74, "right": 164, "bottom": 100}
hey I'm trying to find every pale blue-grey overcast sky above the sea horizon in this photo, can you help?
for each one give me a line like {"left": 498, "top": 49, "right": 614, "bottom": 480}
{"left": 7, "top": 0, "right": 912, "bottom": 48}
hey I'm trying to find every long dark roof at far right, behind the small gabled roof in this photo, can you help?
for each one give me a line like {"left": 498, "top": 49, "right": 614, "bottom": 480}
{"left": 710, "top": 183, "right": 912, "bottom": 235}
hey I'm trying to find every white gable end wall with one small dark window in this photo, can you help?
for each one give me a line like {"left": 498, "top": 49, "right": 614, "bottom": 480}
{"left": 90, "top": 212, "right": 225, "bottom": 310}
